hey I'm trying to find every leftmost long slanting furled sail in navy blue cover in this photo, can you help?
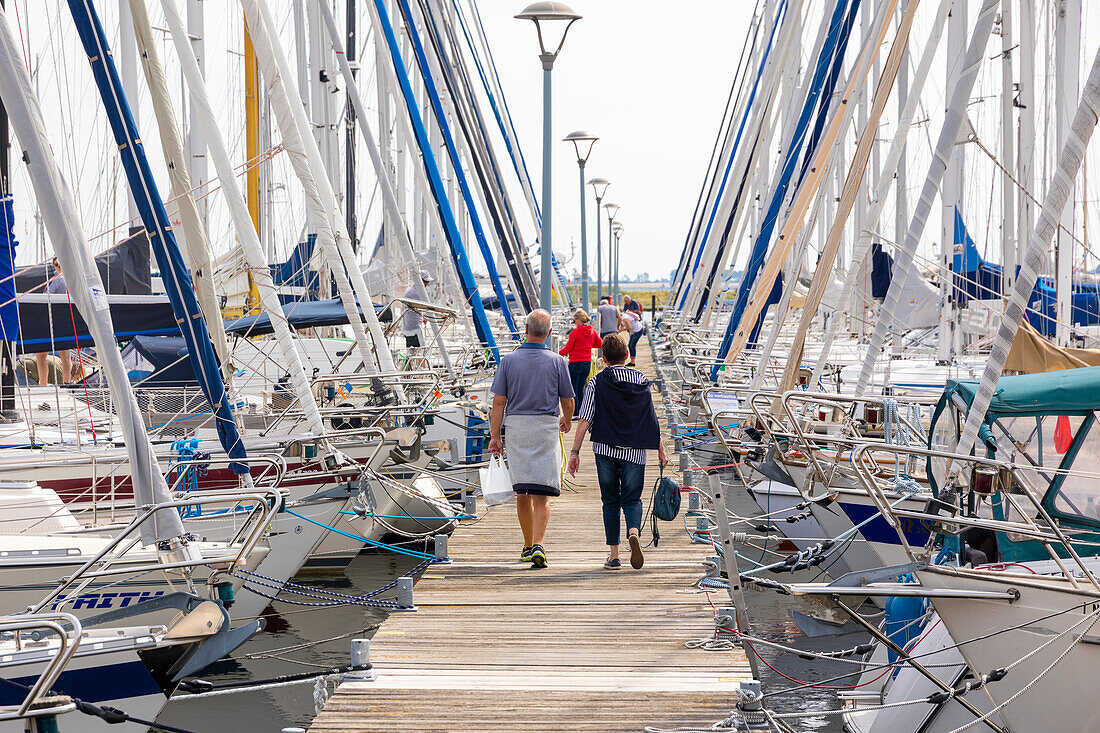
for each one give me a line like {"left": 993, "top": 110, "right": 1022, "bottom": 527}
{"left": 68, "top": 0, "right": 249, "bottom": 473}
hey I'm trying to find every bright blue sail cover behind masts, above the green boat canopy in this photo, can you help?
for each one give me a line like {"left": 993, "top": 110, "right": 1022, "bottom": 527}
{"left": 952, "top": 208, "right": 1100, "bottom": 337}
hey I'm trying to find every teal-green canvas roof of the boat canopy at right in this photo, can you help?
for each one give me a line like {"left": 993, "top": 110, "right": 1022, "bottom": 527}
{"left": 936, "top": 367, "right": 1100, "bottom": 422}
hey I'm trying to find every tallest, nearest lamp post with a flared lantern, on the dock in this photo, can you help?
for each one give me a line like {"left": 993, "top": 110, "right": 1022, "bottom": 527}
{"left": 516, "top": 1, "right": 581, "bottom": 310}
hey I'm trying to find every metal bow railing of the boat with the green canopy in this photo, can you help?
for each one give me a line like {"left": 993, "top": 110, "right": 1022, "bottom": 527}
{"left": 851, "top": 442, "right": 1100, "bottom": 593}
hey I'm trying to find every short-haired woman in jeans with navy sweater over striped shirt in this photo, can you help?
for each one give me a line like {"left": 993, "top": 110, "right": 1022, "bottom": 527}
{"left": 569, "top": 333, "right": 669, "bottom": 570}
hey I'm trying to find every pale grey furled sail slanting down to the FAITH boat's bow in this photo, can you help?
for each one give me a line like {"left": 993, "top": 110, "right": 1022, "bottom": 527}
{"left": 0, "top": 8, "right": 184, "bottom": 544}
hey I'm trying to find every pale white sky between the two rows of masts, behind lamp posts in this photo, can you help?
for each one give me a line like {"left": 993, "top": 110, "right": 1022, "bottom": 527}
{"left": 480, "top": 0, "right": 755, "bottom": 278}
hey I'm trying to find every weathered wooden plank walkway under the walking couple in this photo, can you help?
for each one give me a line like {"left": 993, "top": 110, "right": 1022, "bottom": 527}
{"left": 309, "top": 342, "right": 749, "bottom": 733}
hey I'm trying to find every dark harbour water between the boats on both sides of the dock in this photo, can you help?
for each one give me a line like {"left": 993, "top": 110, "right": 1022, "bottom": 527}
{"left": 158, "top": 508, "right": 866, "bottom": 733}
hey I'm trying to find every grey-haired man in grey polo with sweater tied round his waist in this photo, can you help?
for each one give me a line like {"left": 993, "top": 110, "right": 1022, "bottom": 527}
{"left": 488, "top": 309, "right": 574, "bottom": 568}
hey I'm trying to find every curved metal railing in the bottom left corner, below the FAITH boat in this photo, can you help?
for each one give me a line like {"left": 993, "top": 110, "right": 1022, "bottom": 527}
{"left": 0, "top": 612, "right": 84, "bottom": 727}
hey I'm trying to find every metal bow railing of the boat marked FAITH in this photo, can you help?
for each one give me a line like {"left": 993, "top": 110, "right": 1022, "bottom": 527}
{"left": 29, "top": 489, "right": 283, "bottom": 613}
